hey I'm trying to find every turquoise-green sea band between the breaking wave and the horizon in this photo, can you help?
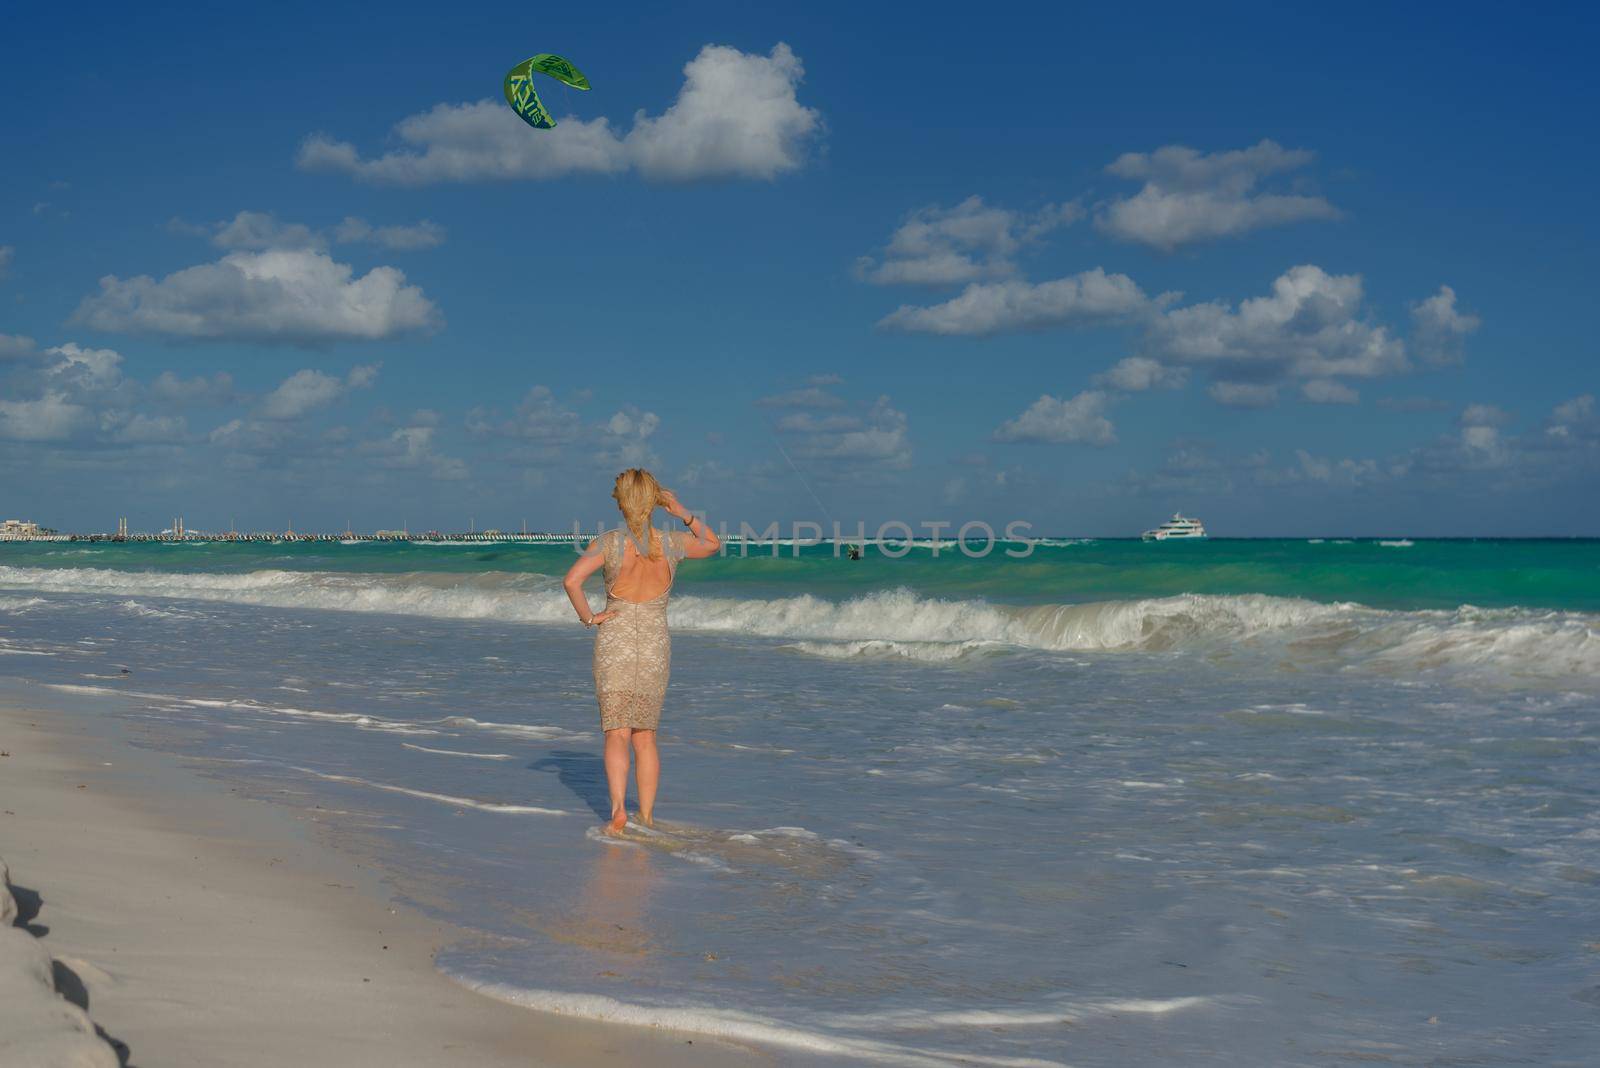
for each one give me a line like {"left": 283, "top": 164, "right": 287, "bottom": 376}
{"left": 9, "top": 537, "right": 1600, "bottom": 612}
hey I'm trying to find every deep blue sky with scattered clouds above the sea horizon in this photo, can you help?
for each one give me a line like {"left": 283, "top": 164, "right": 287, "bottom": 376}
{"left": 0, "top": 5, "right": 1600, "bottom": 534}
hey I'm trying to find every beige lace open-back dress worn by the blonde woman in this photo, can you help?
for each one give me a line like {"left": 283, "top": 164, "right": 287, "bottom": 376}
{"left": 595, "top": 529, "right": 683, "bottom": 731}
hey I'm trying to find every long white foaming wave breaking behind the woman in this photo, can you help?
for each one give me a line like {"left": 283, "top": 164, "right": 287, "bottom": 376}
{"left": 0, "top": 566, "right": 1600, "bottom": 687}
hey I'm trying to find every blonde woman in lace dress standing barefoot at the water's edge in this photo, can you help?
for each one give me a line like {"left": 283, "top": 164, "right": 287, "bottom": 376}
{"left": 563, "top": 467, "right": 722, "bottom": 835}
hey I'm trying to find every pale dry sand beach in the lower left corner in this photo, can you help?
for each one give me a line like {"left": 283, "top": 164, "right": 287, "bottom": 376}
{"left": 0, "top": 700, "right": 765, "bottom": 1068}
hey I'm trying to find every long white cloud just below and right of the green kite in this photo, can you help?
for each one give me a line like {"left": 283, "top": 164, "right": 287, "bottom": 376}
{"left": 296, "top": 43, "right": 821, "bottom": 185}
